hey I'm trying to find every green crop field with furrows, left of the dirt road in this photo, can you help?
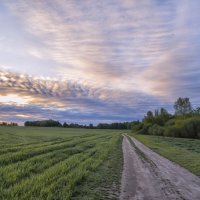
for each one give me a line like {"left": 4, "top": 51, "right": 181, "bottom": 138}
{"left": 0, "top": 127, "right": 122, "bottom": 200}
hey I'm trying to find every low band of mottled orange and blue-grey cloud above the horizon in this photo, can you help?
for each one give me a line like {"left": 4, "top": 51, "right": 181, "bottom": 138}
{"left": 0, "top": 70, "right": 169, "bottom": 120}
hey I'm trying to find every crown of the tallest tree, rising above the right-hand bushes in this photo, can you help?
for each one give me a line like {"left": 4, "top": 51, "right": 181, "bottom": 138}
{"left": 174, "top": 97, "right": 192, "bottom": 116}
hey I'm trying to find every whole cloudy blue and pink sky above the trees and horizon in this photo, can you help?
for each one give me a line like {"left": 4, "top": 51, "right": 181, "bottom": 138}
{"left": 0, "top": 0, "right": 200, "bottom": 124}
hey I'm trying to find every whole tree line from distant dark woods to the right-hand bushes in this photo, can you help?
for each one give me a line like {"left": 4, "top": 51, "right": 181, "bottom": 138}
{"left": 24, "top": 97, "right": 200, "bottom": 138}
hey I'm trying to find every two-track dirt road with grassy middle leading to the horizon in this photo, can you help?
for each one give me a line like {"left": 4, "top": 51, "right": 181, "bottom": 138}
{"left": 120, "top": 136, "right": 200, "bottom": 200}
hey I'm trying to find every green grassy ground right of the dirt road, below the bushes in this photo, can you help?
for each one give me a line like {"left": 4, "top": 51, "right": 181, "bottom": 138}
{"left": 129, "top": 133, "right": 200, "bottom": 176}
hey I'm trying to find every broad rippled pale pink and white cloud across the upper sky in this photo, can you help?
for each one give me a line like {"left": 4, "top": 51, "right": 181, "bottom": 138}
{"left": 3, "top": 1, "right": 175, "bottom": 89}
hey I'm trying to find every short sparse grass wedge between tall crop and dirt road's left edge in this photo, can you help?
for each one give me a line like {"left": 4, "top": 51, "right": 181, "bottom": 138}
{"left": 72, "top": 134, "right": 123, "bottom": 200}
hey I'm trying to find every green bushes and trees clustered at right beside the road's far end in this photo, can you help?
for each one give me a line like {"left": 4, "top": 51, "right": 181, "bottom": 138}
{"left": 132, "top": 97, "right": 200, "bottom": 138}
